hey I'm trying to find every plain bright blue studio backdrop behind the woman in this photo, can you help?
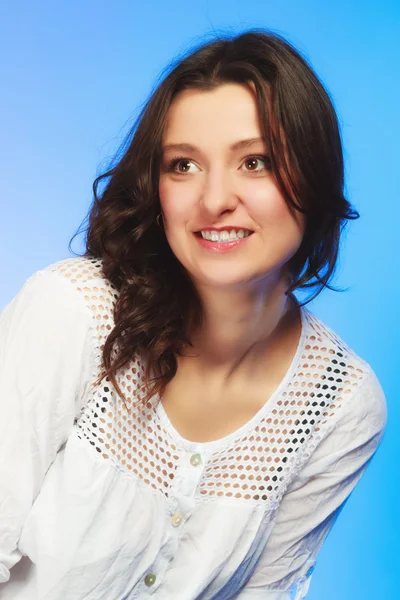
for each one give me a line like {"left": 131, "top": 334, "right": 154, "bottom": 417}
{"left": 0, "top": 0, "right": 400, "bottom": 600}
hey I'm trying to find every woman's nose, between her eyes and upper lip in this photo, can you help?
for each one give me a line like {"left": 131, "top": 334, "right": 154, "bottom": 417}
{"left": 200, "top": 167, "right": 239, "bottom": 218}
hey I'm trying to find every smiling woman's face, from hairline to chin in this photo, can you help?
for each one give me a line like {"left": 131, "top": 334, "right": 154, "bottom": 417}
{"left": 159, "top": 83, "right": 304, "bottom": 288}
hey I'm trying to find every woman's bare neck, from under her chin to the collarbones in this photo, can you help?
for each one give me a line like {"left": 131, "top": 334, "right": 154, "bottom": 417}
{"left": 185, "top": 281, "right": 299, "bottom": 384}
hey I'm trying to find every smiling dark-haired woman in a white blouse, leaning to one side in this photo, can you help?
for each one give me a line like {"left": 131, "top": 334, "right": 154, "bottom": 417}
{"left": 0, "top": 30, "right": 387, "bottom": 600}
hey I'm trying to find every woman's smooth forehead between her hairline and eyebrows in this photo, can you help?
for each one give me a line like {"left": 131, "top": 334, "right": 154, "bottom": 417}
{"left": 163, "top": 83, "right": 261, "bottom": 144}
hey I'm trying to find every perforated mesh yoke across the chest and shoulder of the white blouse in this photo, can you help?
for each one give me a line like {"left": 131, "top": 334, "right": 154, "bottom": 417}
{"left": 48, "top": 257, "right": 364, "bottom": 506}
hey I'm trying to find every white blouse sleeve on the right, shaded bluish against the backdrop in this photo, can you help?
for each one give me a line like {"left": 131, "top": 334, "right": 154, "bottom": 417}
{"left": 235, "top": 370, "right": 387, "bottom": 600}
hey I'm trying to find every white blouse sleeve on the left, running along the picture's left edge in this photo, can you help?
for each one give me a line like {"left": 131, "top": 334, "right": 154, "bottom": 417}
{"left": 0, "top": 270, "right": 94, "bottom": 583}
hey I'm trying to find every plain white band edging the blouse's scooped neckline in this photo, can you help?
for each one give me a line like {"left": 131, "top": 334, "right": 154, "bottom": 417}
{"left": 155, "top": 306, "right": 309, "bottom": 452}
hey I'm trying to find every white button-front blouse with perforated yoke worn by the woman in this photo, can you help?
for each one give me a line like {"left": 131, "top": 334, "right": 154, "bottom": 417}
{"left": 0, "top": 257, "right": 387, "bottom": 600}
